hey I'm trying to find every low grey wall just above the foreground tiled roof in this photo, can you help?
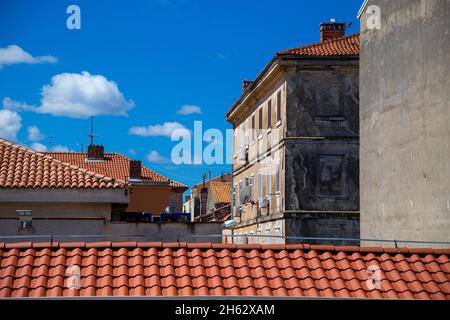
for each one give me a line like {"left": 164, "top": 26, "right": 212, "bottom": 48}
{"left": 0, "top": 219, "right": 222, "bottom": 242}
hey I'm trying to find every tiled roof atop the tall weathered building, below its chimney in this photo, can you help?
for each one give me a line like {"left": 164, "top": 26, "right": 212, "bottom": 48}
{"left": 277, "top": 33, "right": 359, "bottom": 56}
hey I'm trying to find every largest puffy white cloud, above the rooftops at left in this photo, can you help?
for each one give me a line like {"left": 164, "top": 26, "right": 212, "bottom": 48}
{"left": 3, "top": 71, "right": 134, "bottom": 118}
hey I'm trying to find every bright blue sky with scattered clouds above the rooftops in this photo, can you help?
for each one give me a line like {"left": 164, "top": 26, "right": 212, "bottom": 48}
{"left": 0, "top": 0, "right": 362, "bottom": 186}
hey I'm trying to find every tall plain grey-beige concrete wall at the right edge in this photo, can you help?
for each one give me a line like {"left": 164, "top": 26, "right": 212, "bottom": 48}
{"left": 360, "top": 0, "right": 450, "bottom": 247}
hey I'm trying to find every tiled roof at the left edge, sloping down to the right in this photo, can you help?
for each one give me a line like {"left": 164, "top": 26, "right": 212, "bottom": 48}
{"left": 0, "top": 139, "right": 125, "bottom": 189}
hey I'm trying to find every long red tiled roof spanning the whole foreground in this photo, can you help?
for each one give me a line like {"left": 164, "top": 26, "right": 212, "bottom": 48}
{"left": 0, "top": 242, "right": 450, "bottom": 299}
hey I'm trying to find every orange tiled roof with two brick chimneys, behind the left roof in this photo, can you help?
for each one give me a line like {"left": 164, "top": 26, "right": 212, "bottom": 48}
{"left": 45, "top": 152, "right": 187, "bottom": 189}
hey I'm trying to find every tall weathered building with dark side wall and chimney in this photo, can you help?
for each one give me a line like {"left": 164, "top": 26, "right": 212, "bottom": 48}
{"left": 224, "top": 23, "right": 359, "bottom": 243}
